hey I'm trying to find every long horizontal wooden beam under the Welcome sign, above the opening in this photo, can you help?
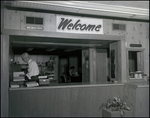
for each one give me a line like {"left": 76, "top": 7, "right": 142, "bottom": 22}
{"left": 2, "top": 29, "right": 124, "bottom": 41}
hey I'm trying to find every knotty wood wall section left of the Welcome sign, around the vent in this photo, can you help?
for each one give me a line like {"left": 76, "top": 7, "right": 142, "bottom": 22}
{"left": 4, "top": 9, "right": 56, "bottom": 32}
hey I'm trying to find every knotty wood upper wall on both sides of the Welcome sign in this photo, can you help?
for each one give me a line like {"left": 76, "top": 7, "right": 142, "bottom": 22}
{"left": 4, "top": 9, "right": 149, "bottom": 75}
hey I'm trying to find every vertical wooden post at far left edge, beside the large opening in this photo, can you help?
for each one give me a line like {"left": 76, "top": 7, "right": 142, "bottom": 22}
{"left": 1, "top": 35, "right": 9, "bottom": 117}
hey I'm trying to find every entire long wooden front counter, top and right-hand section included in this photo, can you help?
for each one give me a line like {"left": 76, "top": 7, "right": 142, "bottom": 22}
{"left": 9, "top": 82, "right": 149, "bottom": 117}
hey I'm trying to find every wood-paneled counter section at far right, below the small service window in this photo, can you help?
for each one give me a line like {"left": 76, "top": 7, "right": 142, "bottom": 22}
{"left": 123, "top": 83, "right": 149, "bottom": 117}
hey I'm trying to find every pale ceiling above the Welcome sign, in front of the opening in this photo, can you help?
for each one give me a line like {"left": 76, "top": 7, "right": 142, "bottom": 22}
{"left": 5, "top": 0, "right": 149, "bottom": 20}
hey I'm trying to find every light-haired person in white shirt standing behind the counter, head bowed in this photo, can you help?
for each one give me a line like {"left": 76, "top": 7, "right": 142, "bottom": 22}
{"left": 21, "top": 52, "right": 39, "bottom": 81}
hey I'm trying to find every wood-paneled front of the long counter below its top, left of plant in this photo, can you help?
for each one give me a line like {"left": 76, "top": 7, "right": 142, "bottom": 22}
{"left": 9, "top": 85, "right": 123, "bottom": 117}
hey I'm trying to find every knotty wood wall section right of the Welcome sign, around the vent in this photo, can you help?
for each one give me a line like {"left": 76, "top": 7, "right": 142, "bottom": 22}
{"left": 104, "top": 19, "right": 149, "bottom": 75}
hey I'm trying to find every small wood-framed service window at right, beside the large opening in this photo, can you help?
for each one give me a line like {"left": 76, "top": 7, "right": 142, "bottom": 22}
{"left": 127, "top": 48, "right": 144, "bottom": 81}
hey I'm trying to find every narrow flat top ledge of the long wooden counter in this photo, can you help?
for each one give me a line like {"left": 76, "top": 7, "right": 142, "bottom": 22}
{"left": 9, "top": 82, "right": 124, "bottom": 90}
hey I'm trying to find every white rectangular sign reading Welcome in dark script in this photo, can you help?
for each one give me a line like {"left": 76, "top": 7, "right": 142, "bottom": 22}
{"left": 56, "top": 15, "right": 103, "bottom": 34}
